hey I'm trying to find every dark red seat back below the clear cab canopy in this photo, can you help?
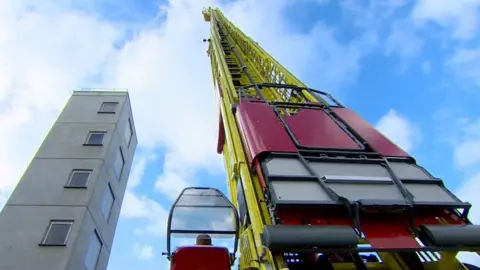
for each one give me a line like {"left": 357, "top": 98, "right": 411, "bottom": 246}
{"left": 170, "top": 246, "right": 230, "bottom": 270}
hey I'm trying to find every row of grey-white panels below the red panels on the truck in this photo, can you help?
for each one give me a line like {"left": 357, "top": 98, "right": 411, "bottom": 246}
{"left": 267, "top": 158, "right": 457, "bottom": 206}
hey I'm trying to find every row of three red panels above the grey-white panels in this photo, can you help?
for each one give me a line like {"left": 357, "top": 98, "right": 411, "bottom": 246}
{"left": 230, "top": 100, "right": 410, "bottom": 162}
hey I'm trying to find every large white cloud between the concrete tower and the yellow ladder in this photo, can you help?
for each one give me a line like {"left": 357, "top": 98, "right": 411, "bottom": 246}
{"left": 99, "top": 1, "right": 225, "bottom": 204}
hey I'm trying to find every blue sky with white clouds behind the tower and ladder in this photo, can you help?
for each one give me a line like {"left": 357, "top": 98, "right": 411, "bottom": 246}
{"left": 0, "top": 0, "right": 480, "bottom": 270}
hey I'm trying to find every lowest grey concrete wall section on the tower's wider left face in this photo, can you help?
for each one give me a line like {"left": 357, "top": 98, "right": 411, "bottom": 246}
{"left": 0, "top": 205, "right": 86, "bottom": 270}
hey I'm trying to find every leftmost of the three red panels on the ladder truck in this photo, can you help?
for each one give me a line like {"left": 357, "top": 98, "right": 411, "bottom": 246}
{"left": 236, "top": 101, "right": 297, "bottom": 162}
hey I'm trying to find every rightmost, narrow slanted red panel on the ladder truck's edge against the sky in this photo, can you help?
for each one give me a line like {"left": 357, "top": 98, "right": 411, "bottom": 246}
{"left": 332, "top": 108, "right": 410, "bottom": 157}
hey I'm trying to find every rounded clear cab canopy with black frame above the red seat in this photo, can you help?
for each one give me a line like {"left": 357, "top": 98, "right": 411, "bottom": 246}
{"left": 164, "top": 187, "right": 240, "bottom": 265}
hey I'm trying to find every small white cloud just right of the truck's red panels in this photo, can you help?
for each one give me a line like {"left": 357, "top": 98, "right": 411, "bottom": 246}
{"left": 376, "top": 109, "right": 422, "bottom": 152}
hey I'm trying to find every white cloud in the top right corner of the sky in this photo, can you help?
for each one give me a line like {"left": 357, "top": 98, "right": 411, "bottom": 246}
{"left": 412, "top": 0, "right": 480, "bottom": 39}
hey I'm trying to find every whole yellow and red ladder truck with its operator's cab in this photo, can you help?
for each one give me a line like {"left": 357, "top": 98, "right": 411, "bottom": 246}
{"left": 166, "top": 8, "right": 480, "bottom": 270}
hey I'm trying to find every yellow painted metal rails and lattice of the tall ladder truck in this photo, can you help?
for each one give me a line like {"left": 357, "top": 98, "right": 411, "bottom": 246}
{"left": 203, "top": 8, "right": 472, "bottom": 270}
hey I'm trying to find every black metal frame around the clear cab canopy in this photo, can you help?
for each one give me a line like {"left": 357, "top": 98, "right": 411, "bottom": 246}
{"left": 163, "top": 187, "right": 240, "bottom": 265}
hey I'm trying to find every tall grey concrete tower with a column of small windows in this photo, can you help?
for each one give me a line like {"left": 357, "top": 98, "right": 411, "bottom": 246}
{"left": 0, "top": 91, "right": 137, "bottom": 270}
